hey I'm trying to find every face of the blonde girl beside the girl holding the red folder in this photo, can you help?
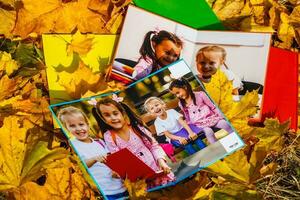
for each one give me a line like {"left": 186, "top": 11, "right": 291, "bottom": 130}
{"left": 65, "top": 113, "right": 89, "bottom": 141}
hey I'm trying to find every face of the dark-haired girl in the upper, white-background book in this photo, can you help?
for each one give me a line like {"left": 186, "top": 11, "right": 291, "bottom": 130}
{"left": 154, "top": 40, "right": 181, "bottom": 67}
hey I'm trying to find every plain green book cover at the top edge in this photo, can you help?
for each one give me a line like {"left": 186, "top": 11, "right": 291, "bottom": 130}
{"left": 133, "top": 0, "right": 225, "bottom": 30}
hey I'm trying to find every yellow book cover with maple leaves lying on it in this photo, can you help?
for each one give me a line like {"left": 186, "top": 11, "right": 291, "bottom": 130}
{"left": 42, "top": 32, "right": 118, "bottom": 104}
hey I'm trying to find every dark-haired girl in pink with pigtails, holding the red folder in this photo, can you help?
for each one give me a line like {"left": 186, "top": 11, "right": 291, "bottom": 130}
{"left": 92, "top": 95, "right": 175, "bottom": 189}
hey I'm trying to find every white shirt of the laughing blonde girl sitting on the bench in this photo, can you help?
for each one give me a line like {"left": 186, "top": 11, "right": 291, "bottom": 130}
{"left": 154, "top": 109, "right": 183, "bottom": 135}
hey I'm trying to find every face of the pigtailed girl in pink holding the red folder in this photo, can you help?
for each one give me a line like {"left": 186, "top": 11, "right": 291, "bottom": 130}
{"left": 99, "top": 104, "right": 126, "bottom": 129}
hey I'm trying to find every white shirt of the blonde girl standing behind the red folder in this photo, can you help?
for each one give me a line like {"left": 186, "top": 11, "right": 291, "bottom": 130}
{"left": 71, "top": 139, "right": 126, "bottom": 195}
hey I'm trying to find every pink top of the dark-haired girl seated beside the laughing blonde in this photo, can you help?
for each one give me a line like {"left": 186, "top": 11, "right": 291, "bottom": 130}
{"left": 179, "top": 91, "right": 223, "bottom": 128}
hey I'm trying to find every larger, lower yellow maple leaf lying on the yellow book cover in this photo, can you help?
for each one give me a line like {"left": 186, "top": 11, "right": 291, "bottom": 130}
{"left": 58, "top": 62, "right": 107, "bottom": 99}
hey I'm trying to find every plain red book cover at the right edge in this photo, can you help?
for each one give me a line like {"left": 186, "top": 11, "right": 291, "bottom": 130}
{"left": 261, "top": 47, "right": 298, "bottom": 130}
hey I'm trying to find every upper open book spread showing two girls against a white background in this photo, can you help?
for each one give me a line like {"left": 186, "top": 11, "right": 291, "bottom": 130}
{"left": 110, "top": 6, "right": 271, "bottom": 114}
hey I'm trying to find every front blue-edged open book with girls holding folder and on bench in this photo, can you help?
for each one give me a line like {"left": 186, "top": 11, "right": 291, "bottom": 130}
{"left": 51, "top": 60, "right": 244, "bottom": 199}
